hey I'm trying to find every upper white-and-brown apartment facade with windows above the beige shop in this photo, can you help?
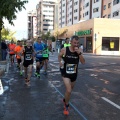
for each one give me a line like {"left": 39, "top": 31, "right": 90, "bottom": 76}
{"left": 59, "top": 0, "right": 120, "bottom": 28}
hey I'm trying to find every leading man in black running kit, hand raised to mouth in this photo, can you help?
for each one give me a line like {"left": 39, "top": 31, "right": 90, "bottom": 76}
{"left": 58, "top": 36, "right": 85, "bottom": 115}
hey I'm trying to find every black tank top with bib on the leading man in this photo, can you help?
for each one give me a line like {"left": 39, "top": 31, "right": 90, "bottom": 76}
{"left": 64, "top": 47, "right": 79, "bottom": 76}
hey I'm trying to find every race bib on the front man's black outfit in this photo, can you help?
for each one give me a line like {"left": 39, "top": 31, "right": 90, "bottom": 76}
{"left": 66, "top": 64, "right": 77, "bottom": 74}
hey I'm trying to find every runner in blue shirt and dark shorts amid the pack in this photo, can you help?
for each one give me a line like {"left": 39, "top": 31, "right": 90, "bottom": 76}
{"left": 34, "top": 37, "right": 45, "bottom": 78}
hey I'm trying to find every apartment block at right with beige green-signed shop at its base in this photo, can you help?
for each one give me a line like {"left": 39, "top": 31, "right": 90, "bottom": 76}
{"left": 59, "top": 0, "right": 120, "bottom": 55}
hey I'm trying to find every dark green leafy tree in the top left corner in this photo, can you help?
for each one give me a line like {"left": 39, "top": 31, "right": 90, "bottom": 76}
{"left": 0, "top": 0, "right": 28, "bottom": 59}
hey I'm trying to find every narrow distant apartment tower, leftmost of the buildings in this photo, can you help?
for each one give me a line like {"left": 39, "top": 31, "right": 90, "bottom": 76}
{"left": 27, "top": 10, "right": 37, "bottom": 39}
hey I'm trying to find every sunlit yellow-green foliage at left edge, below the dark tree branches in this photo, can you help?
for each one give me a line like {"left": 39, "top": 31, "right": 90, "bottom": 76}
{"left": 1, "top": 28, "right": 16, "bottom": 40}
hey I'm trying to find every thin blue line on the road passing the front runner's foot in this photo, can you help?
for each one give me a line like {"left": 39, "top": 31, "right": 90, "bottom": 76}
{"left": 49, "top": 81, "right": 87, "bottom": 120}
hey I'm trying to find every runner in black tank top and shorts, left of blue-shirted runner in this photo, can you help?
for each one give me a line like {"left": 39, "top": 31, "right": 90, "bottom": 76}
{"left": 23, "top": 40, "right": 34, "bottom": 86}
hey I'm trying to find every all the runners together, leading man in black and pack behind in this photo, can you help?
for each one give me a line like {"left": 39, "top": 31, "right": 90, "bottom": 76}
{"left": 9, "top": 36, "right": 85, "bottom": 115}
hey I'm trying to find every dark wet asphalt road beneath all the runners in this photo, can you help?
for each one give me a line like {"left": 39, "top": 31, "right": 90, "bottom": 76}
{"left": 0, "top": 53, "right": 120, "bottom": 120}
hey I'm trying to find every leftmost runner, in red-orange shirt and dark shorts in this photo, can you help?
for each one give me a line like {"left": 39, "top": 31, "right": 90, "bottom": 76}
{"left": 8, "top": 40, "right": 16, "bottom": 65}
